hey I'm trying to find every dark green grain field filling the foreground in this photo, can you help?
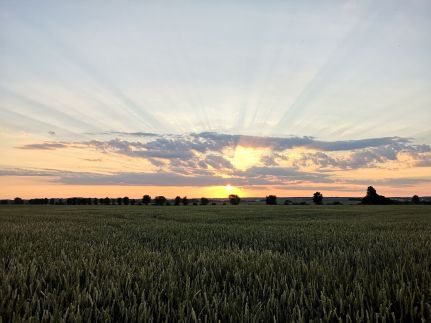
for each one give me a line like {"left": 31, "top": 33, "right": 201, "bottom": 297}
{"left": 0, "top": 205, "right": 431, "bottom": 322}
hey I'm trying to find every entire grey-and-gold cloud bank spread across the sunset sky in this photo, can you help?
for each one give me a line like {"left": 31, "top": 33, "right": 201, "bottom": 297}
{"left": 6, "top": 131, "right": 431, "bottom": 186}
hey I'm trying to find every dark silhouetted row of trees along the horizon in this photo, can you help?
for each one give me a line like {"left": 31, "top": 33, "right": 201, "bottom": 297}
{"left": 0, "top": 186, "right": 431, "bottom": 206}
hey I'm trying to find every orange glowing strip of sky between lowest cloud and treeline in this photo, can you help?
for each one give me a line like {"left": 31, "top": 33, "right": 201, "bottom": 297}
{"left": 0, "top": 176, "right": 430, "bottom": 199}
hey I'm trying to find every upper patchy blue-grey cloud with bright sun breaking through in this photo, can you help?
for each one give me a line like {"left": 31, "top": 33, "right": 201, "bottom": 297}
{"left": 15, "top": 131, "right": 431, "bottom": 174}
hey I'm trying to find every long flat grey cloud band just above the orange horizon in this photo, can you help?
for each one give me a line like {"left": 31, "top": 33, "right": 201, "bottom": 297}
{"left": 0, "top": 167, "right": 431, "bottom": 191}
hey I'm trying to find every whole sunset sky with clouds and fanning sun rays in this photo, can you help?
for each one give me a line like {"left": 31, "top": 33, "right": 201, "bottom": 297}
{"left": 0, "top": 0, "right": 431, "bottom": 198}
